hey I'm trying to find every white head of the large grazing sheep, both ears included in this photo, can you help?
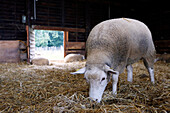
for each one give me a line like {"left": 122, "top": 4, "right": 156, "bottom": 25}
{"left": 71, "top": 65, "right": 117, "bottom": 102}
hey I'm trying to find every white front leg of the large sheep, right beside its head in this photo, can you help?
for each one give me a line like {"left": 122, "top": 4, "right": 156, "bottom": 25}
{"left": 112, "top": 73, "right": 119, "bottom": 95}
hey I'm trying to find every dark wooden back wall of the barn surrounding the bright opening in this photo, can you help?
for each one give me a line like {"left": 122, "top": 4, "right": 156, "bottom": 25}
{"left": 0, "top": 0, "right": 170, "bottom": 62}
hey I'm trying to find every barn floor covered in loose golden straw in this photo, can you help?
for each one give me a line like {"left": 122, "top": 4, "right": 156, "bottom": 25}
{"left": 0, "top": 61, "right": 170, "bottom": 113}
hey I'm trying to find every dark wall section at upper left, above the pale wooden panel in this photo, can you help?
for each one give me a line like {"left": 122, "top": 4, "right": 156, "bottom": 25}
{"left": 0, "top": 0, "right": 26, "bottom": 40}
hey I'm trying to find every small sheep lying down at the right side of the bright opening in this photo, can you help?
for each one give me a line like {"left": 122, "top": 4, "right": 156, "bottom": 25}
{"left": 64, "top": 54, "right": 85, "bottom": 63}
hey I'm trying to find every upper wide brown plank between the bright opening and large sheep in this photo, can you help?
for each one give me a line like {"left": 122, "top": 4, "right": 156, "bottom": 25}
{"left": 66, "top": 42, "right": 85, "bottom": 49}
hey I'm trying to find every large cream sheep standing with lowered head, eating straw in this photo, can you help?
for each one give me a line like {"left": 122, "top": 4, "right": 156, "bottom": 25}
{"left": 71, "top": 18, "right": 155, "bottom": 102}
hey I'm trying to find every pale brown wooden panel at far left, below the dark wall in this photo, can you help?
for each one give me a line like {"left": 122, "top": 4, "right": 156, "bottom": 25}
{"left": 0, "top": 41, "right": 20, "bottom": 63}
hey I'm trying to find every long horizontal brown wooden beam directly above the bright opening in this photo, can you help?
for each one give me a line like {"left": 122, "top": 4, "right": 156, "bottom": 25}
{"left": 32, "top": 25, "right": 85, "bottom": 32}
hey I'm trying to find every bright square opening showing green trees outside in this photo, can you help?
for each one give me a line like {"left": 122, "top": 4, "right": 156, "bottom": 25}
{"left": 34, "top": 30, "right": 64, "bottom": 60}
